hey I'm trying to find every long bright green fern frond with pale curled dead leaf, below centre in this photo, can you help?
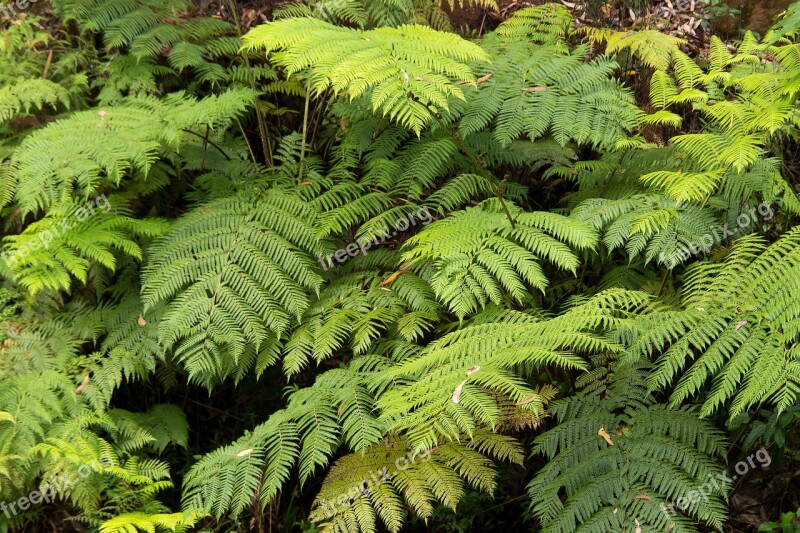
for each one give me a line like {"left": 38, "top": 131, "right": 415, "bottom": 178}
{"left": 379, "top": 291, "right": 642, "bottom": 448}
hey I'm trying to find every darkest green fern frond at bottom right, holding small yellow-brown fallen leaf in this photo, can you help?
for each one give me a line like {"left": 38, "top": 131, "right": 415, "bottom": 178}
{"left": 528, "top": 363, "right": 728, "bottom": 532}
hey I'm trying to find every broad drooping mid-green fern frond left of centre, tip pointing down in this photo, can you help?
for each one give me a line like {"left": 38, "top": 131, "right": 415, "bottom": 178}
{"left": 142, "top": 190, "right": 322, "bottom": 386}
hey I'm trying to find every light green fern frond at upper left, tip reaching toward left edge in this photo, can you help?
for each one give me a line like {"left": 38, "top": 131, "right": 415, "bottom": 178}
{"left": 12, "top": 89, "right": 253, "bottom": 212}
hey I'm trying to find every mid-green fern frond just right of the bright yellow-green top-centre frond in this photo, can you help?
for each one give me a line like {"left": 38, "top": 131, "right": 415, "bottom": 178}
{"left": 459, "top": 21, "right": 641, "bottom": 146}
